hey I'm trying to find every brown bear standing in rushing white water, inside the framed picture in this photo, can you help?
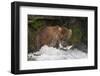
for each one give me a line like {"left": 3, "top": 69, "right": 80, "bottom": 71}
{"left": 35, "top": 25, "right": 72, "bottom": 50}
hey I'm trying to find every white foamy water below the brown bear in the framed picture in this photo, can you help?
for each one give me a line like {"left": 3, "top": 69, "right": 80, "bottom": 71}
{"left": 28, "top": 45, "right": 87, "bottom": 61}
